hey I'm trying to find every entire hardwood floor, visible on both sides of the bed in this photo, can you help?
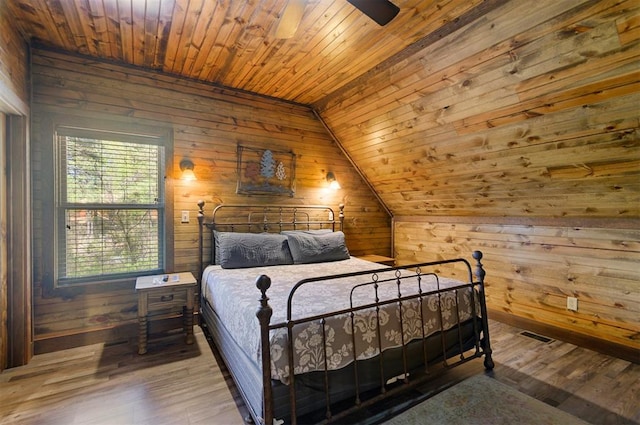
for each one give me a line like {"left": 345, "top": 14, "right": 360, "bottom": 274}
{"left": 0, "top": 321, "right": 640, "bottom": 425}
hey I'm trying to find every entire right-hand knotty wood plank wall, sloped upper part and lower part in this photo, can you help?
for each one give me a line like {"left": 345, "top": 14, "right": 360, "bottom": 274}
{"left": 315, "top": 0, "right": 640, "bottom": 354}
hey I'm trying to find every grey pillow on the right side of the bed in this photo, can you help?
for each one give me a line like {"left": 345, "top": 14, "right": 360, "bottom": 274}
{"left": 282, "top": 231, "right": 349, "bottom": 264}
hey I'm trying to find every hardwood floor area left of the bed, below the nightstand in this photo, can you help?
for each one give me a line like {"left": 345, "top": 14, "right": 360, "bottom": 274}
{"left": 0, "top": 327, "right": 245, "bottom": 425}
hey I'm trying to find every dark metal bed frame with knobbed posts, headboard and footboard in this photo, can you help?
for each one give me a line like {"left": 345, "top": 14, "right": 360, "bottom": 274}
{"left": 198, "top": 201, "right": 494, "bottom": 425}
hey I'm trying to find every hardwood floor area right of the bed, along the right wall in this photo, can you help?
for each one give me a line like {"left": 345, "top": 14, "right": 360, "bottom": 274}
{"left": 490, "top": 321, "right": 640, "bottom": 425}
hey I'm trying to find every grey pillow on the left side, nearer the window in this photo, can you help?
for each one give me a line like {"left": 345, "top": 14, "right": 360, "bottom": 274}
{"left": 214, "top": 232, "right": 293, "bottom": 269}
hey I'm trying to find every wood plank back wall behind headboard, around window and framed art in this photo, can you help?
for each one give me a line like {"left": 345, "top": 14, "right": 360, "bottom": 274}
{"left": 32, "top": 48, "right": 391, "bottom": 352}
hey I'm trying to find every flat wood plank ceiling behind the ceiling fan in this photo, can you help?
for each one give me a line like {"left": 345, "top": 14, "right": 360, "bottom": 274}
{"left": 8, "top": 0, "right": 484, "bottom": 105}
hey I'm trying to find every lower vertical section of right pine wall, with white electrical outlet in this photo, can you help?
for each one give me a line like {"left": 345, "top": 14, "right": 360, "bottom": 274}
{"left": 394, "top": 216, "right": 640, "bottom": 348}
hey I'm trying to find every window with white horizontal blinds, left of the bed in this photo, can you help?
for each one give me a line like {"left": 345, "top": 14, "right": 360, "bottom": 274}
{"left": 54, "top": 126, "right": 167, "bottom": 287}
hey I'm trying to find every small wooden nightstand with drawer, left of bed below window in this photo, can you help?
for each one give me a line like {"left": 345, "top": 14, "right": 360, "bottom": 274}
{"left": 136, "top": 272, "right": 196, "bottom": 354}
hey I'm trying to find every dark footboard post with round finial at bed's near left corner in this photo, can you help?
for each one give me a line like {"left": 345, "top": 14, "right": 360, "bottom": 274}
{"left": 256, "top": 275, "right": 273, "bottom": 425}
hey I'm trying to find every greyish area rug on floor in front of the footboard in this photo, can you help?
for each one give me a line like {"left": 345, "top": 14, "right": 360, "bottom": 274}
{"left": 384, "top": 375, "right": 587, "bottom": 425}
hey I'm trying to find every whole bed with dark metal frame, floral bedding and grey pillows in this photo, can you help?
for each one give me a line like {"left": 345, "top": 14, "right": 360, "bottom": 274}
{"left": 198, "top": 201, "right": 493, "bottom": 424}
